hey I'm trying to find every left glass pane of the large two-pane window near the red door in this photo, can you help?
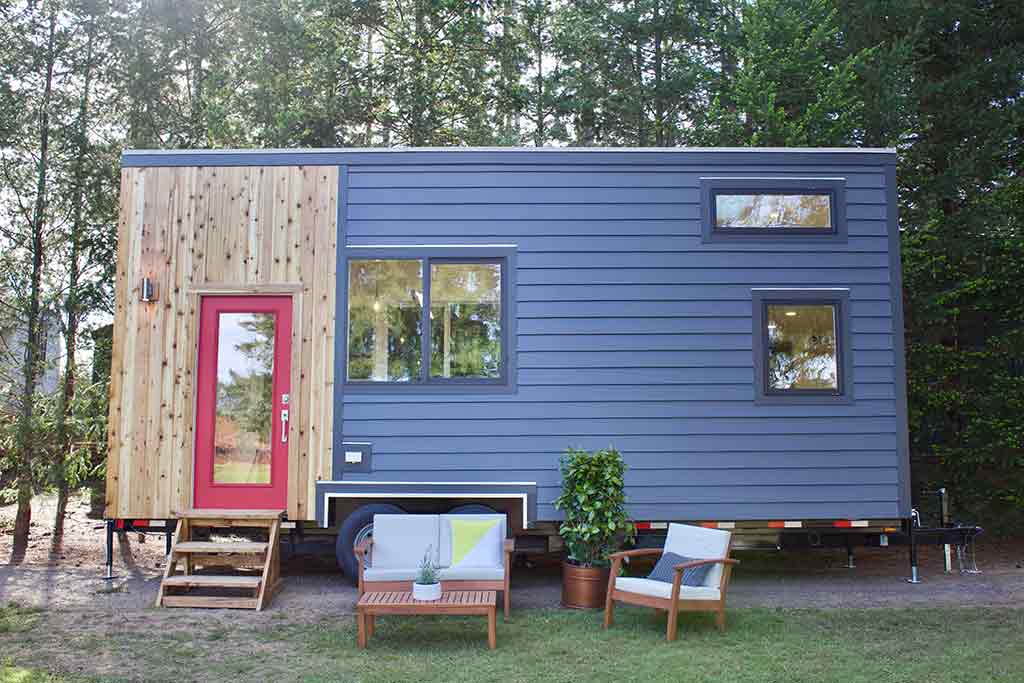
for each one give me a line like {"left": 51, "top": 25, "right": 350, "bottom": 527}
{"left": 348, "top": 259, "right": 423, "bottom": 382}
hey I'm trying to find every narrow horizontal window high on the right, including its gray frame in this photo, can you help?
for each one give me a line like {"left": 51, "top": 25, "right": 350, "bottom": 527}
{"left": 700, "top": 178, "right": 847, "bottom": 242}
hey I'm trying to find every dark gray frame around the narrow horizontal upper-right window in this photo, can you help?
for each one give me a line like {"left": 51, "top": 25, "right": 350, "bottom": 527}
{"left": 700, "top": 177, "right": 847, "bottom": 243}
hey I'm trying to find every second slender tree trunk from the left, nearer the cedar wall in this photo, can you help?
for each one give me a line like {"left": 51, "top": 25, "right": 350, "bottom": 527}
{"left": 53, "top": 6, "right": 96, "bottom": 539}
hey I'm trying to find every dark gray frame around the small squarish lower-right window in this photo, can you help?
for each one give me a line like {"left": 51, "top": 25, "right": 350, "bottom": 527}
{"left": 751, "top": 289, "right": 854, "bottom": 405}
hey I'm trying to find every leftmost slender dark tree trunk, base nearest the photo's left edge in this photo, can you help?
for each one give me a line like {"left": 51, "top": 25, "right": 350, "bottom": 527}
{"left": 12, "top": 8, "right": 57, "bottom": 557}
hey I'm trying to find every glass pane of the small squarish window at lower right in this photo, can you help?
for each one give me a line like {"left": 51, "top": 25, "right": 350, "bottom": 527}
{"left": 766, "top": 303, "right": 839, "bottom": 391}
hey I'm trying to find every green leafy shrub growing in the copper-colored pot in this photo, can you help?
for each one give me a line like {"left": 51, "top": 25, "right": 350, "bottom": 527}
{"left": 555, "top": 446, "right": 636, "bottom": 567}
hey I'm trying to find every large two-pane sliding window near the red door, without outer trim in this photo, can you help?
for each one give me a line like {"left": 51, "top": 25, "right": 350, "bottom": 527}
{"left": 347, "top": 256, "right": 508, "bottom": 385}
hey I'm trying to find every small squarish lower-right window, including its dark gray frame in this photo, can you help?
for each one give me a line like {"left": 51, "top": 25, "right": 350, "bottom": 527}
{"left": 754, "top": 290, "right": 852, "bottom": 402}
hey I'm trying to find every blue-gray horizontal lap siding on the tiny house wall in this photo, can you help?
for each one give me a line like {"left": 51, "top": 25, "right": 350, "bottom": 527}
{"left": 336, "top": 157, "right": 901, "bottom": 519}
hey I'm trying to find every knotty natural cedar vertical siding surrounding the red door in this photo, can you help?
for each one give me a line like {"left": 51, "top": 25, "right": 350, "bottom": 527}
{"left": 106, "top": 163, "right": 338, "bottom": 519}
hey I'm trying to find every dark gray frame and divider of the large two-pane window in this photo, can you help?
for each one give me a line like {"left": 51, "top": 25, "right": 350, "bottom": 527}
{"left": 338, "top": 245, "right": 516, "bottom": 393}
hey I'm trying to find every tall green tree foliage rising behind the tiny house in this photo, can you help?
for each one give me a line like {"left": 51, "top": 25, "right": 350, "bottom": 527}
{"left": 0, "top": 0, "right": 1024, "bottom": 528}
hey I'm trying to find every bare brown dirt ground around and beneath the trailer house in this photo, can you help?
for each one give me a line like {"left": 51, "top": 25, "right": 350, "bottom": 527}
{"left": 0, "top": 491, "right": 1024, "bottom": 680}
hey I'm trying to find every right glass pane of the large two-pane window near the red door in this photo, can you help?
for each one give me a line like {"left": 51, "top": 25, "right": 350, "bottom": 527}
{"left": 430, "top": 263, "right": 502, "bottom": 379}
